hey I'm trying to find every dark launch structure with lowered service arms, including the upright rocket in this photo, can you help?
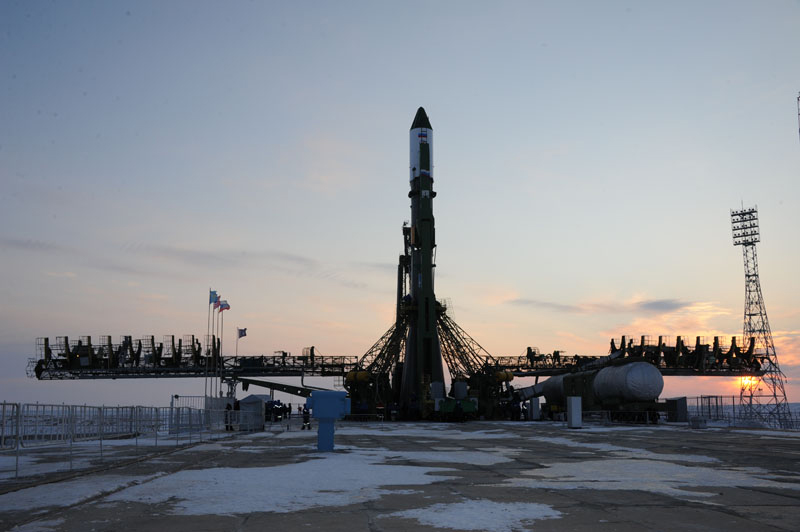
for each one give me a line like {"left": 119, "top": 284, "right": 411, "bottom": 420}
{"left": 28, "top": 107, "right": 769, "bottom": 419}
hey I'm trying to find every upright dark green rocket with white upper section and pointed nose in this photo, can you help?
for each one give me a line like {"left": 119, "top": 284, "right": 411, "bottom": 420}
{"left": 401, "top": 107, "right": 444, "bottom": 417}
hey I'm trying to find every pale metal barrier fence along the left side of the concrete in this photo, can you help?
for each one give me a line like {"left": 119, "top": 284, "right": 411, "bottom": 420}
{"left": 0, "top": 403, "right": 264, "bottom": 481}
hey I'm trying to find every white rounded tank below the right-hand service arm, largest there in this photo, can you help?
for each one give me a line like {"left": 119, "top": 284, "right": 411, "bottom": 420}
{"left": 593, "top": 362, "right": 664, "bottom": 401}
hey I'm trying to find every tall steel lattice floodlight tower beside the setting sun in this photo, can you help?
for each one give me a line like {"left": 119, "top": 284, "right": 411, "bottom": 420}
{"left": 731, "top": 207, "right": 792, "bottom": 428}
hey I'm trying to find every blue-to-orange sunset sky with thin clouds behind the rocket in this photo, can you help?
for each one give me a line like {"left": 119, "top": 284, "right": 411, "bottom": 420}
{"left": 0, "top": 0, "right": 800, "bottom": 404}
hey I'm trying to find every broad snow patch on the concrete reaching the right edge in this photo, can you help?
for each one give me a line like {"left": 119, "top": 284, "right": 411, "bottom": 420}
{"left": 505, "top": 459, "right": 800, "bottom": 500}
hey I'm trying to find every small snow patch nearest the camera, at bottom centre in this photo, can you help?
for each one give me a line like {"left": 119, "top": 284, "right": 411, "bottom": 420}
{"left": 381, "top": 499, "right": 561, "bottom": 532}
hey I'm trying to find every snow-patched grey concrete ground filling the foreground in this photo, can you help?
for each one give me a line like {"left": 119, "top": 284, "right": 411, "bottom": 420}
{"left": 0, "top": 422, "right": 800, "bottom": 532}
